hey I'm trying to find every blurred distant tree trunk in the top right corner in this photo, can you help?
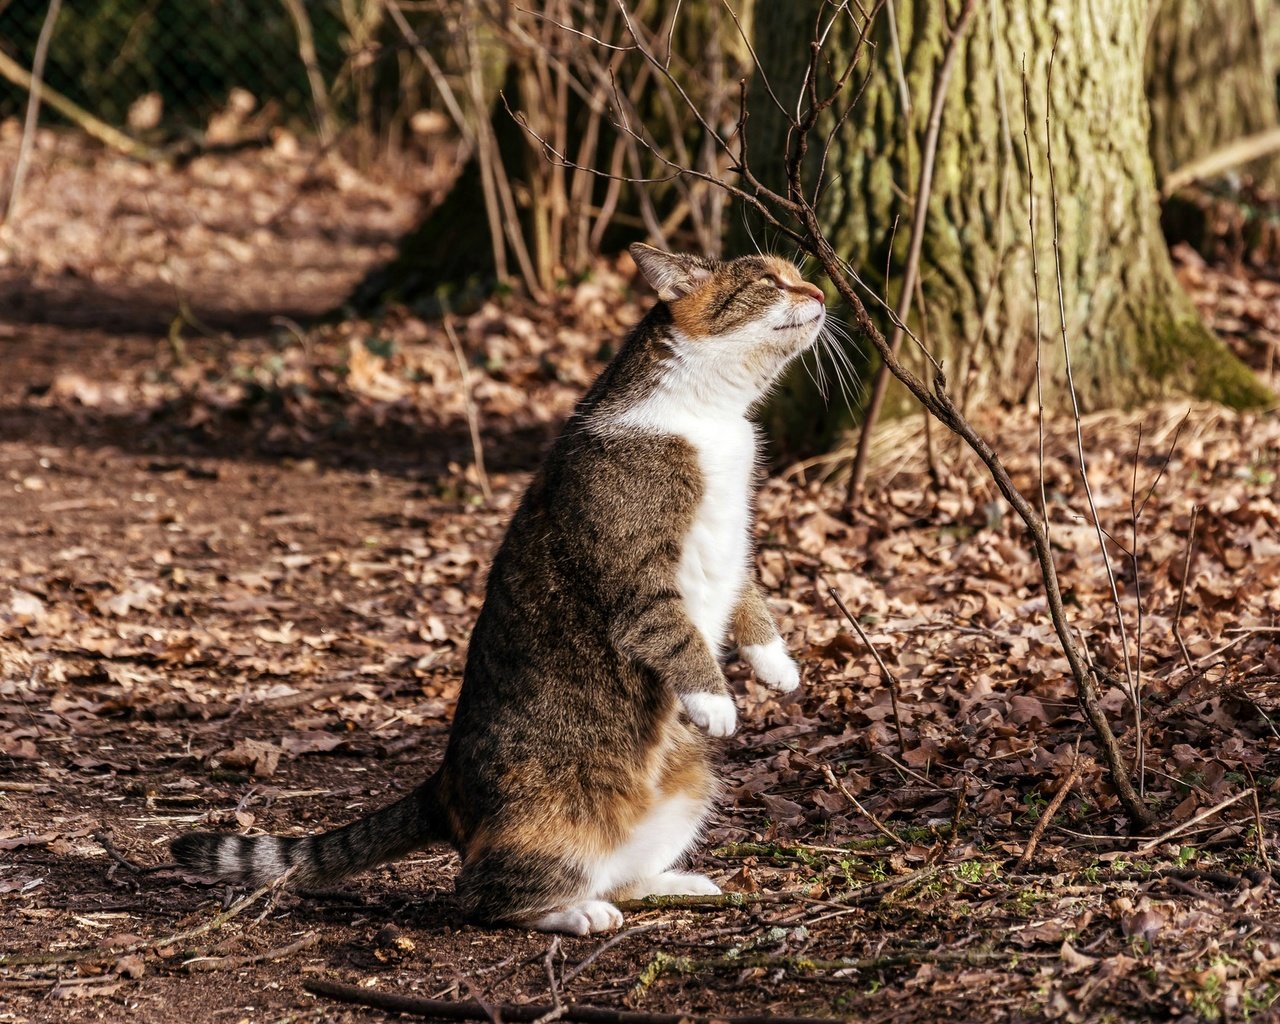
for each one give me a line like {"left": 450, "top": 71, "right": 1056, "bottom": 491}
{"left": 1147, "top": 0, "right": 1280, "bottom": 188}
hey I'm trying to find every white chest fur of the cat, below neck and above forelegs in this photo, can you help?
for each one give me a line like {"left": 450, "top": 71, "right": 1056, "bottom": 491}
{"left": 676, "top": 417, "right": 755, "bottom": 655}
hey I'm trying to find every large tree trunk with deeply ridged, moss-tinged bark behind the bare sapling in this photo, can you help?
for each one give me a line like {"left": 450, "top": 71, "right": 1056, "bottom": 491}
{"left": 748, "top": 0, "right": 1274, "bottom": 448}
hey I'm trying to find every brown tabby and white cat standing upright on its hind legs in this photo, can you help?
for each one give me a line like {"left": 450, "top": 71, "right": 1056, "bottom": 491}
{"left": 173, "top": 244, "right": 826, "bottom": 934}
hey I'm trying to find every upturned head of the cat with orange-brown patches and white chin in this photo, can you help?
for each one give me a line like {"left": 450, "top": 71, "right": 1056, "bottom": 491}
{"left": 631, "top": 242, "right": 827, "bottom": 407}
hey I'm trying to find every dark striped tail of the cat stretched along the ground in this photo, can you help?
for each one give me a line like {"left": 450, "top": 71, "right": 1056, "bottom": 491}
{"left": 169, "top": 778, "right": 447, "bottom": 888}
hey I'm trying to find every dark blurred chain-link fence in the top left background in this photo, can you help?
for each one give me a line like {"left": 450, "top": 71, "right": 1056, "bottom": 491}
{"left": 0, "top": 0, "right": 380, "bottom": 137}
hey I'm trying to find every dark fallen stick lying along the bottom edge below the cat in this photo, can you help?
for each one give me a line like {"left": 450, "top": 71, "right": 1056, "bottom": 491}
{"left": 302, "top": 979, "right": 840, "bottom": 1024}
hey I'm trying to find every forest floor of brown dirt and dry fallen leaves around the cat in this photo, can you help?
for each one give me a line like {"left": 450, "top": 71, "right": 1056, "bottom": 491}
{"left": 0, "top": 131, "right": 1280, "bottom": 1024}
